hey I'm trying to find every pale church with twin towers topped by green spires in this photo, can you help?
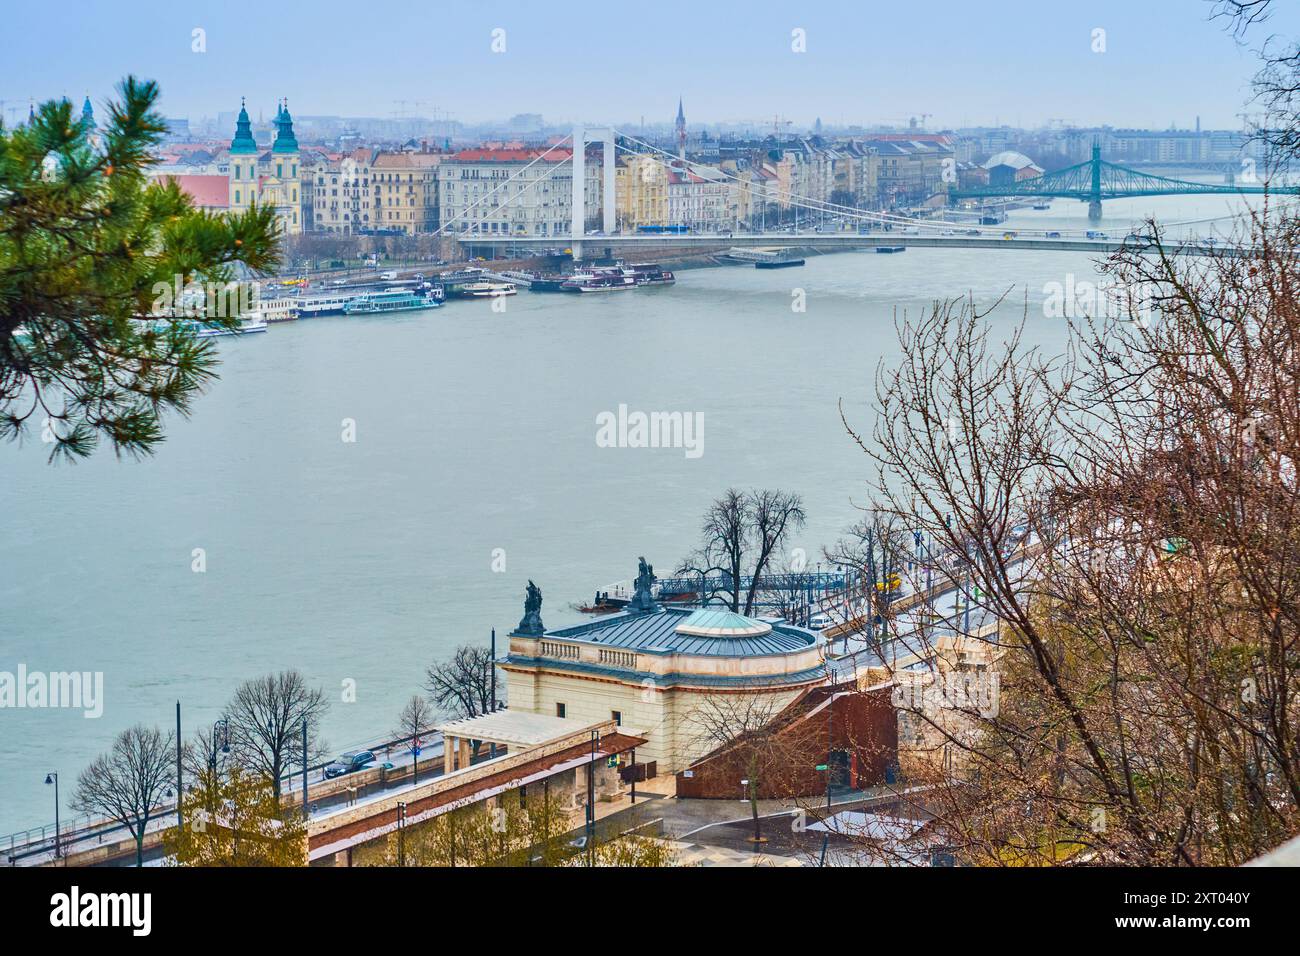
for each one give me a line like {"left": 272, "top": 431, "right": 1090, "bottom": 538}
{"left": 229, "top": 103, "right": 303, "bottom": 235}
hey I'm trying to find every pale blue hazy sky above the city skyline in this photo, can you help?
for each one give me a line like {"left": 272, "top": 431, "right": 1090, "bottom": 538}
{"left": 0, "top": 0, "right": 1300, "bottom": 129}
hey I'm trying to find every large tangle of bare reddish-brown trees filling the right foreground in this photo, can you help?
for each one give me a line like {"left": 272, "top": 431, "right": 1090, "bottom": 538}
{"left": 842, "top": 184, "right": 1300, "bottom": 865}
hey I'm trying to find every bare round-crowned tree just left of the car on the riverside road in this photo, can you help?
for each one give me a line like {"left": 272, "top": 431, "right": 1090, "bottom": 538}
{"left": 225, "top": 670, "right": 329, "bottom": 800}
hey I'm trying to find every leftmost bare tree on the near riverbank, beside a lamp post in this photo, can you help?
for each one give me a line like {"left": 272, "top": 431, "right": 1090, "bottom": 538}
{"left": 72, "top": 723, "right": 178, "bottom": 866}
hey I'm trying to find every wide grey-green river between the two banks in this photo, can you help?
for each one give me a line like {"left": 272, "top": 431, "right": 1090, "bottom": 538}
{"left": 0, "top": 196, "right": 1258, "bottom": 834}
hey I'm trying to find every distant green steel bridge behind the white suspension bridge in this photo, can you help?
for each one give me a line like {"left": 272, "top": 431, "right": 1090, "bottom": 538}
{"left": 948, "top": 143, "right": 1300, "bottom": 219}
